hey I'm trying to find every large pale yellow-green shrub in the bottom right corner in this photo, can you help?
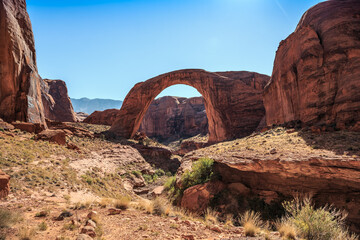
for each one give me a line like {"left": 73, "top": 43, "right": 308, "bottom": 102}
{"left": 283, "top": 198, "right": 357, "bottom": 240}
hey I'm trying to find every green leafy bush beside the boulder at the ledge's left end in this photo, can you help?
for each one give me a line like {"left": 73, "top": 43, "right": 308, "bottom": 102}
{"left": 181, "top": 158, "right": 214, "bottom": 190}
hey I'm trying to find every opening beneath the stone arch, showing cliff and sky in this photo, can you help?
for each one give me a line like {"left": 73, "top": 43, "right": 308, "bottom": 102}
{"left": 137, "top": 84, "right": 209, "bottom": 145}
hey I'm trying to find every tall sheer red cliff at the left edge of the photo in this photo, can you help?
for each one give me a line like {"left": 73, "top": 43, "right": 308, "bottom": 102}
{"left": 0, "top": 0, "right": 45, "bottom": 124}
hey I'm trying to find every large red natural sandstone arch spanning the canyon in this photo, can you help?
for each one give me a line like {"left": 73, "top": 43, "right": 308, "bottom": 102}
{"left": 110, "top": 69, "right": 269, "bottom": 142}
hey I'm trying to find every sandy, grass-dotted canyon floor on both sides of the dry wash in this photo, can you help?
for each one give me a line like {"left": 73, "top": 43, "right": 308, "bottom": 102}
{"left": 0, "top": 123, "right": 360, "bottom": 240}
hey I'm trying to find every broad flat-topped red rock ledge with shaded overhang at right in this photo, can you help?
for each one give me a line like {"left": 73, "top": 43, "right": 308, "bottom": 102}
{"left": 178, "top": 128, "right": 360, "bottom": 232}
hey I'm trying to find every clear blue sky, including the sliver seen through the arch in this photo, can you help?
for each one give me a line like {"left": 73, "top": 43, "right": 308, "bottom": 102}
{"left": 27, "top": 0, "right": 320, "bottom": 100}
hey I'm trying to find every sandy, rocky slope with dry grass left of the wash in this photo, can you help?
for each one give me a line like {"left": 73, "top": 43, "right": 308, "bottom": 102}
{"left": 0, "top": 123, "right": 277, "bottom": 239}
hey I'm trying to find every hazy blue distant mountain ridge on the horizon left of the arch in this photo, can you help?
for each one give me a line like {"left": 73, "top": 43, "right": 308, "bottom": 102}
{"left": 71, "top": 98, "right": 123, "bottom": 114}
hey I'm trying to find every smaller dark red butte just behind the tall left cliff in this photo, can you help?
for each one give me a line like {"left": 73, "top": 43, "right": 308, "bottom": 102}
{"left": 42, "top": 79, "right": 77, "bottom": 122}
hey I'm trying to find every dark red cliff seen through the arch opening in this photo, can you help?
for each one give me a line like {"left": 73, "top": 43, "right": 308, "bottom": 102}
{"left": 139, "top": 96, "right": 208, "bottom": 141}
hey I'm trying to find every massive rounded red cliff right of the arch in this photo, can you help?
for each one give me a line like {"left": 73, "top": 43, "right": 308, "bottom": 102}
{"left": 264, "top": 0, "right": 360, "bottom": 130}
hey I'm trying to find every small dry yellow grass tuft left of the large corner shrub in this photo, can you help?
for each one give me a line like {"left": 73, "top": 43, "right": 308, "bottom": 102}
{"left": 239, "top": 211, "right": 264, "bottom": 237}
